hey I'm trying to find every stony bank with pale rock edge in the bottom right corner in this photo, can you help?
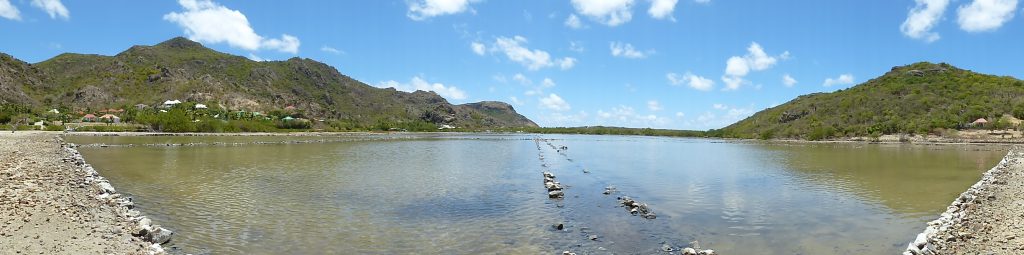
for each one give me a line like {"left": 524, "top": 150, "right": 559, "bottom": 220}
{"left": 903, "top": 145, "right": 1024, "bottom": 255}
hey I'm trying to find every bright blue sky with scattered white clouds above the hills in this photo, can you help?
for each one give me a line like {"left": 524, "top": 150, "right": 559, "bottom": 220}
{"left": 0, "top": 0, "right": 1024, "bottom": 130}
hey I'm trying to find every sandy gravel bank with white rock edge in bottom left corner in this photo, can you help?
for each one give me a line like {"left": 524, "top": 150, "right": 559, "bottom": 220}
{"left": 0, "top": 132, "right": 172, "bottom": 254}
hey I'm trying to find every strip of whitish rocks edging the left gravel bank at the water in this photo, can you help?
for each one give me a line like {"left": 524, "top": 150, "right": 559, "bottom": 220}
{"left": 60, "top": 139, "right": 174, "bottom": 254}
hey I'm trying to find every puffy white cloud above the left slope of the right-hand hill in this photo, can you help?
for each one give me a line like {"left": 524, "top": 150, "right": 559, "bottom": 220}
{"left": 722, "top": 42, "right": 790, "bottom": 90}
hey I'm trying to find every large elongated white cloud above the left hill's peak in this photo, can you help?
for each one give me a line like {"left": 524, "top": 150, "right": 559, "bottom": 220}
{"left": 164, "top": 0, "right": 300, "bottom": 54}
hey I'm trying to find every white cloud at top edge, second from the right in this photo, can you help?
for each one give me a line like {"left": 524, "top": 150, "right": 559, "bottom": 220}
{"left": 899, "top": 0, "right": 949, "bottom": 42}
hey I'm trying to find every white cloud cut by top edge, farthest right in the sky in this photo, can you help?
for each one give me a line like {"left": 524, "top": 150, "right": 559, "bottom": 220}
{"left": 956, "top": 0, "right": 1017, "bottom": 32}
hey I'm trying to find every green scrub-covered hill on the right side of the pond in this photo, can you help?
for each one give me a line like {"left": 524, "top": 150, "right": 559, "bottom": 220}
{"left": 709, "top": 62, "right": 1024, "bottom": 139}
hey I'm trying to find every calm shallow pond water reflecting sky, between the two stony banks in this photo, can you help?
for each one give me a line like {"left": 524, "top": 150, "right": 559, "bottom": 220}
{"left": 68, "top": 135, "right": 1007, "bottom": 254}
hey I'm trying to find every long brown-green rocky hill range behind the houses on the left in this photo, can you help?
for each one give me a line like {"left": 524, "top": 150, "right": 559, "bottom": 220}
{"left": 0, "top": 37, "right": 537, "bottom": 128}
